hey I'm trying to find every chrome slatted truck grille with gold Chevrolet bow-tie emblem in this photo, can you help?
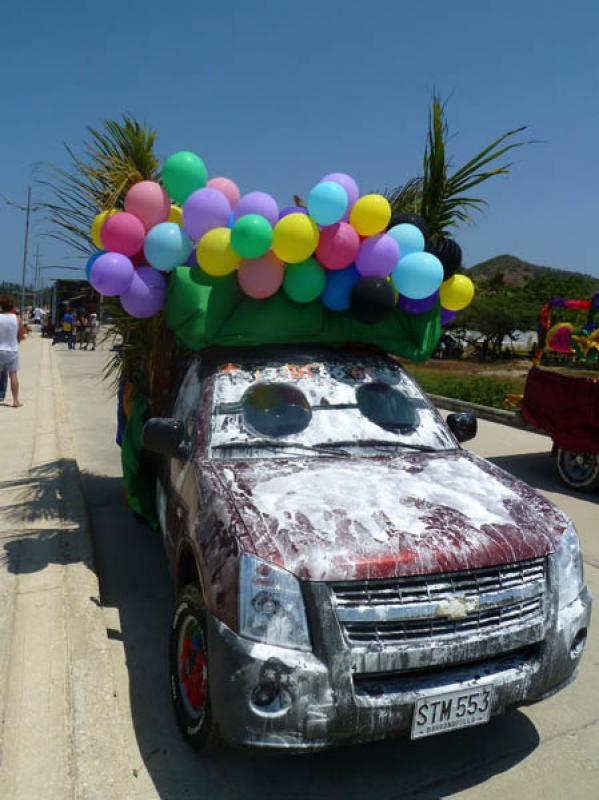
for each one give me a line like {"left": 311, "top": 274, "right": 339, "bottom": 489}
{"left": 330, "top": 558, "right": 546, "bottom": 648}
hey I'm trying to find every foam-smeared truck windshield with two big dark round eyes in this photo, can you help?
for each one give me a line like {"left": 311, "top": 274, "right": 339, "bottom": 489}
{"left": 210, "top": 359, "right": 455, "bottom": 458}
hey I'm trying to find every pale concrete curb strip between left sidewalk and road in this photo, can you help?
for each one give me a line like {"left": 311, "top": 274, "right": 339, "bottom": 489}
{"left": 50, "top": 350, "right": 135, "bottom": 800}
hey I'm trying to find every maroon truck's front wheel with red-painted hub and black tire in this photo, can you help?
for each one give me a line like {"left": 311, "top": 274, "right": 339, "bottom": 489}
{"left": 170, "top": 583, "right": 220, "bottom": 755}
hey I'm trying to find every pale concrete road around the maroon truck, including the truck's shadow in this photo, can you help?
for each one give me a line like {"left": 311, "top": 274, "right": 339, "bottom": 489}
{"left": 52, "top": 346, "right": 599, "bottom": 800}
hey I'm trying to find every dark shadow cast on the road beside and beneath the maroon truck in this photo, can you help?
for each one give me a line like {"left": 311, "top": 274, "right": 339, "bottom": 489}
{"left": 78, "top": 474, "right": 539, "bottom": 800}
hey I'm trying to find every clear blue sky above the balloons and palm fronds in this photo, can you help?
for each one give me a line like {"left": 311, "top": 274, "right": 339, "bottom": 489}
{"left": 0, "top": 0, "right": 599, "bottom": 279}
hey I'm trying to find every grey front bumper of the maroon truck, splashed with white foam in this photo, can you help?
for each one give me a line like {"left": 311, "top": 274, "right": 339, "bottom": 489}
{"left": 208, "top": 587, "right": 592, "bottom": 750}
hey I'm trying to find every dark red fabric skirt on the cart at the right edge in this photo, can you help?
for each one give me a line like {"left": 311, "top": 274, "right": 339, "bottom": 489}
{"left": 521, "top": 367, "right": 599, "bottom": 454}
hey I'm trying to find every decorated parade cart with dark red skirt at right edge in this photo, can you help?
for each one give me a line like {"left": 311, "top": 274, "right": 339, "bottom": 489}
{"left": 520, "top": 294, "right": 599, "bottom": 491}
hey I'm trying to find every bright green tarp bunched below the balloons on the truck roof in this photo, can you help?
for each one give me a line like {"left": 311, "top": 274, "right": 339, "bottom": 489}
{"left": 166, "top": 267, "right": 441, "bottom": 361}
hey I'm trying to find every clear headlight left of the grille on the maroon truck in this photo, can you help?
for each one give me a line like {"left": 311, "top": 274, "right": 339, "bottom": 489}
{"left": 239, "top": 553, "right": 311, "bottom": 650}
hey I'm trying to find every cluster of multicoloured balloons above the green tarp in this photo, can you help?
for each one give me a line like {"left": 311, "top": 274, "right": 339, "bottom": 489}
{"left": 87, "top": 152, "right": 474, "bottom": 324}
